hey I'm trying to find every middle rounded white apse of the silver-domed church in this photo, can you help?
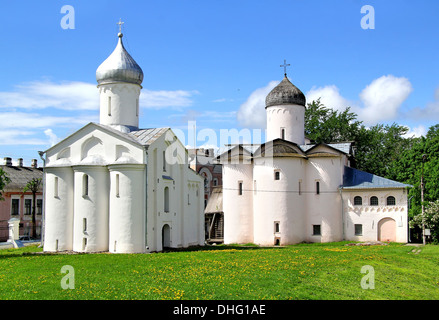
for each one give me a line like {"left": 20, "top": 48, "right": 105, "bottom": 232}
{"left": 73, "top": 166, "right": 110, "bottom": 252}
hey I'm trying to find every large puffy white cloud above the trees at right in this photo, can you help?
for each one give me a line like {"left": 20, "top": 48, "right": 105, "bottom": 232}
{"left": 354, "top": 75, "right": 413, "bottom": 124}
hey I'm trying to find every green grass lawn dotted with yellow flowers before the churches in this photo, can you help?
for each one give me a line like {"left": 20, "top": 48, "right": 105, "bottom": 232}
{"left": 0, "top": 243, "right": 439, "bottom": 300}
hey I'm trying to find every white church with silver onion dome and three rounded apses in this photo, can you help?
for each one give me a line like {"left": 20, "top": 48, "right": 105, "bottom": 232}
{"left": 44, "top": 29, "right": 204, "bottom": 253}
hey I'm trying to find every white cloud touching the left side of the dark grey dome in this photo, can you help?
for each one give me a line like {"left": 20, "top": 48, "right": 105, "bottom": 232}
{"left": 236, "top": 81, "right": 279, "bottom": 129}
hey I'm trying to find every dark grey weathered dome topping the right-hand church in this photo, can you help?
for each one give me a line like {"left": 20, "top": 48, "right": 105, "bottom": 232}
{"left": 265, "top": 76, "right": 306, "bottom": 108}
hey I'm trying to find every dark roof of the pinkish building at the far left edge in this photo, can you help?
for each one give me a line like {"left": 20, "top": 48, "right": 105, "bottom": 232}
{"left": 0, "top": 165, "right": 43, "bottom": 192}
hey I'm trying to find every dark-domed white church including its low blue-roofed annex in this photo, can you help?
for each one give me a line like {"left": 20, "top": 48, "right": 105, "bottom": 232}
{"left": 218, "top": 74, "right": 409, "bottom": 246}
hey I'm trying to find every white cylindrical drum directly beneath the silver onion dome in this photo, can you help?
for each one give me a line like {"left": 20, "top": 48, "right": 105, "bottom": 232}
{"left": 99, "top": 83, "right": 141, "bottom": 128}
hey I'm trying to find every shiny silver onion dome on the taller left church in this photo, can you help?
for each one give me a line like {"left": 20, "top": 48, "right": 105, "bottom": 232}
{"left": 96, "top": 33, "right": 143, "bottom": 85}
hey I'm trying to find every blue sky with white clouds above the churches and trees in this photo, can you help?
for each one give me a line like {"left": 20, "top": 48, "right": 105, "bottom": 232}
{"left": 0, "top": 0, "right": 439, "bottom": 165}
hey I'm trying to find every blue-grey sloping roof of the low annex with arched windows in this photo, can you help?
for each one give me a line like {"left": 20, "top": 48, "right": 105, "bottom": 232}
{"left": 342, "top": 166, "right": 412, "bottom": 189}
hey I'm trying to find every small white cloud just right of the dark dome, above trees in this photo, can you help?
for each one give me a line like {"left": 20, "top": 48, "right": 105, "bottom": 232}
{"left": 306, "top": 85, "right": 352, "bottom": 111}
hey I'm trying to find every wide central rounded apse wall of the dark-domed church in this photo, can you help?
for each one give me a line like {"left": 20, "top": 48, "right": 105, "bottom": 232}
{"left": 253, "top": 157, "right": 306, "bottom": 245}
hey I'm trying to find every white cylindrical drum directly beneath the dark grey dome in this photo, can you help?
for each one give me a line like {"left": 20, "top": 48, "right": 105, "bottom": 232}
{"left": 266, "top": 104, "right": 305, "bottom": 145}
